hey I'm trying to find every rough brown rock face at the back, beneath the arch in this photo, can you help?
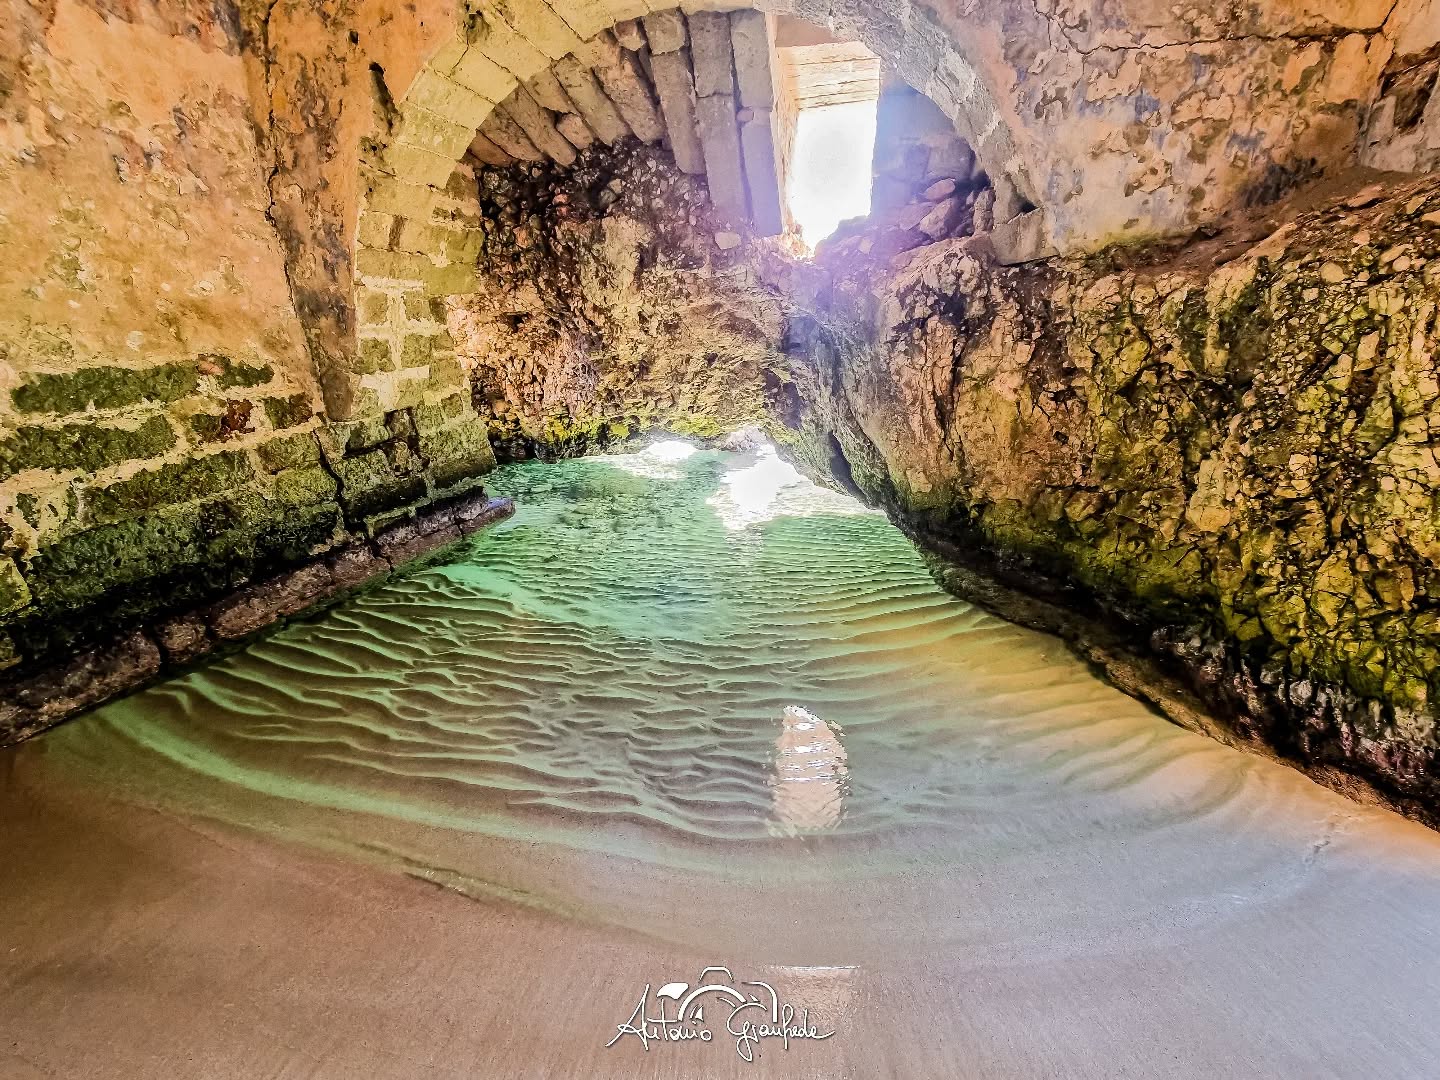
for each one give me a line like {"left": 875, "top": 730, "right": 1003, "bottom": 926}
{"left": 449, "top": 147, "right": 786, "bottom": 458}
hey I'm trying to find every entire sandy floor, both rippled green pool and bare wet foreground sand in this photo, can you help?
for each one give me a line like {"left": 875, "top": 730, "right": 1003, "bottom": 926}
{"left": 0, "top": 444, "right": 1440, "bottom": 1080}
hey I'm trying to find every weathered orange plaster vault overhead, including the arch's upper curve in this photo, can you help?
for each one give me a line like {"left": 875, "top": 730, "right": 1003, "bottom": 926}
{"left": 227, "top": 0, "right": 1440, "bottom": 423}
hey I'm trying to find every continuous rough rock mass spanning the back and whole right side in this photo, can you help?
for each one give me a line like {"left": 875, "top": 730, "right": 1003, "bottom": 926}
{"left": 452, "top": 135, "right": 1440, "bottom": 814}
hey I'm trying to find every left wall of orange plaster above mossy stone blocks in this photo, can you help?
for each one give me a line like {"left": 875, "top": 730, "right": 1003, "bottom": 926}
{"left": 0, "top": 0, "right": 492, "bottom": 720}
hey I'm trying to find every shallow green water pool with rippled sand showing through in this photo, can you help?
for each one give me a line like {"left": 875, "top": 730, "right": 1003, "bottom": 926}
{"left": 55, "top": 440, "right": 1370, "bottom": 919}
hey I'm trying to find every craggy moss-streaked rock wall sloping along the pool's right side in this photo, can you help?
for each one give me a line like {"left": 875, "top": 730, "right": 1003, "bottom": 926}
{"left": 792, "top": 180, "right": 1440, "bottom": 808}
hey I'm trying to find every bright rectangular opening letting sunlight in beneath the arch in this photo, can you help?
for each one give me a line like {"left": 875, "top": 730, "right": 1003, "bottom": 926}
{"left": 775, "top": 19, "right": 880, "bottom": 249}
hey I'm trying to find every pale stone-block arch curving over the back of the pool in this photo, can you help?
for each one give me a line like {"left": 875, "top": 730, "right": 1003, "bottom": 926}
{"left": 339, "top": 0, "right": 1035, "bottom": 419}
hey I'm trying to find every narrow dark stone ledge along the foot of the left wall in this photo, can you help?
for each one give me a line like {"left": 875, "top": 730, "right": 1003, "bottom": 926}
{"left": 0, "top": 492, "right": 516, "bottom": 746}
